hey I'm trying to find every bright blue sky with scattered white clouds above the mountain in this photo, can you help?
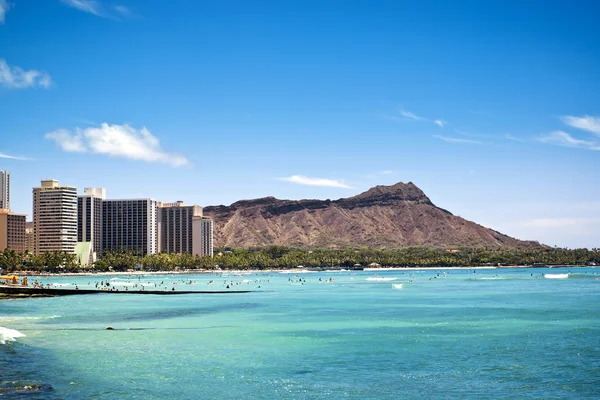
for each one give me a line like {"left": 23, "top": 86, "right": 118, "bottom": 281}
{"left": 0, "top": 0, "right": 600, "bottom": 248}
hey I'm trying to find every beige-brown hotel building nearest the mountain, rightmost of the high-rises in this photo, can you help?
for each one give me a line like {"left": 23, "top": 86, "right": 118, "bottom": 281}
{"left": 158, "top": 201, "right": 213, "bottom": 257}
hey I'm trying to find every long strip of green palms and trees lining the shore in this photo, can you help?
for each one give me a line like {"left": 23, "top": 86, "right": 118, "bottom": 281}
{"left": 0, "top": 246, "right": 600, "bottom": 273}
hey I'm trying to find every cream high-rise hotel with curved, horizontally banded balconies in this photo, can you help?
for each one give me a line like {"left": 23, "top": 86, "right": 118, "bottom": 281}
{"left": 33, "top": 180, "right": 77, "bottom": 254}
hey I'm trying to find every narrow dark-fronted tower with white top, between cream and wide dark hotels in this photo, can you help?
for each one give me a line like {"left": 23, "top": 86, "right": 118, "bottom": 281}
{"left": 77, "top": 188, "right": 106, "bottom": 254}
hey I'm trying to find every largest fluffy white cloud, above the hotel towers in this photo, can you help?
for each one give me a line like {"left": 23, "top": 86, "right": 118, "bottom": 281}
{"left": 44, "top": 123, "right": 190, "bottom": 167}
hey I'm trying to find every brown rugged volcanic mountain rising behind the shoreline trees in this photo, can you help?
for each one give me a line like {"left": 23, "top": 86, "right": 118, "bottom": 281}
{"left": 204, "top": 182, "right": 540, "bottom": 248}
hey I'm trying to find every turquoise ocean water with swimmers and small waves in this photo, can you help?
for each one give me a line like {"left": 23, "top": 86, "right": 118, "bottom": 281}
{"left": 0, "top": 268, "right": 600, "bottom": 399}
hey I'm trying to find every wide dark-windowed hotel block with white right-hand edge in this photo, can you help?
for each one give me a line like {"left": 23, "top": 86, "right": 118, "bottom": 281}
{"left": 102, "top": 199, "right": 158, "bottom": 255}
